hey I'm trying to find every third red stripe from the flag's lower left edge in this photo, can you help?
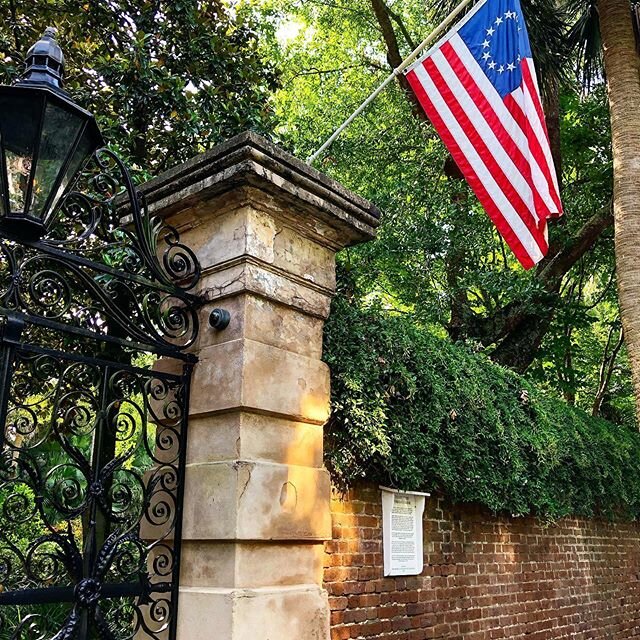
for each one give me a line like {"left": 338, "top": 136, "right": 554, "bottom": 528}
{"left": 442, "top": 42, "right": 551, "bottom": 218}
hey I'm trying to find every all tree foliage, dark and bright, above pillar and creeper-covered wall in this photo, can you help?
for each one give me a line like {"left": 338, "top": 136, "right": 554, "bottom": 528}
{"left": 0, "top": 0, "right": 632, "bottom": 421}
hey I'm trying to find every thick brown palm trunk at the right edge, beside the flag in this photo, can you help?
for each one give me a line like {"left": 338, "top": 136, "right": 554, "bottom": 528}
{"left": 598, "top": 0, "right": 640, "bottom": 417}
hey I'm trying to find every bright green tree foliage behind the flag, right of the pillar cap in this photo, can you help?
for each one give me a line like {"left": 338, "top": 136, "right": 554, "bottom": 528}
{"left": 260, "top": 0, "right": 634, "bottom": 424}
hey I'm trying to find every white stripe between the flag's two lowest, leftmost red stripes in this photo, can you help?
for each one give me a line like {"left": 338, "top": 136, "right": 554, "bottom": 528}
{"left": 413, "top": 64, "right": 544, "bottom": 263}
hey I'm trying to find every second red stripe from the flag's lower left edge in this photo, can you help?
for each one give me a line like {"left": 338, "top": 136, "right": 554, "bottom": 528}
{"left": 423, "top": 58, "right": 547, "bottom": 254}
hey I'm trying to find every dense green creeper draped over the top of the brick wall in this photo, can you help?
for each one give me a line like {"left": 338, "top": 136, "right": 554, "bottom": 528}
{"left": 324, "top": 293, "right": 640, "bottom": 519}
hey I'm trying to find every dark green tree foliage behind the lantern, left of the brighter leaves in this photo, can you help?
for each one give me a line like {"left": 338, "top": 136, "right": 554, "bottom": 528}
{"left": 0, "top": 0, "right": 277, "bottom": 175}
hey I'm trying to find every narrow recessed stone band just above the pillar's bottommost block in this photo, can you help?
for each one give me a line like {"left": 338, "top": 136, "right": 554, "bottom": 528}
{"left": 180, "top": 541, "right": 324, "bottom": 588}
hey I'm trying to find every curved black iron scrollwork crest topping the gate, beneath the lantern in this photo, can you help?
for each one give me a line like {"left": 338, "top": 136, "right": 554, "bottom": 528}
{"left": 0, "top": 149, "right": 200, "bottom": 356}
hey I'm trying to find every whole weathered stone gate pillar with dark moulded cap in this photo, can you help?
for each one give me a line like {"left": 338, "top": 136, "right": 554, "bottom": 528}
{"left": 143, "top": 133, "right": 378, "bottom": 640}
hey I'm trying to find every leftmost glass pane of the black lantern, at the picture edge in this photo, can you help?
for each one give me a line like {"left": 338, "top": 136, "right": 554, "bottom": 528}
{"left": 0, "top": 93, "right": 43, "bottom": 213}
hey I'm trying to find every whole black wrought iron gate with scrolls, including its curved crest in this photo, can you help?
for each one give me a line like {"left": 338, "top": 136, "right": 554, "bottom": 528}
{"left": 0, "top": 150, "right": 200, "bottom": 640}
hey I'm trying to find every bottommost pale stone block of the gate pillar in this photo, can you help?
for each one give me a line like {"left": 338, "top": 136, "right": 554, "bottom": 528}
{"left": 178, "top": 585, "right": 329, "bottom": 640}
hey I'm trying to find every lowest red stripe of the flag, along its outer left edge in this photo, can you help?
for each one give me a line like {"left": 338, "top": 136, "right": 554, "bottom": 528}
{"left": 406, "top": 70, "right": 535, "bottom": 269}
